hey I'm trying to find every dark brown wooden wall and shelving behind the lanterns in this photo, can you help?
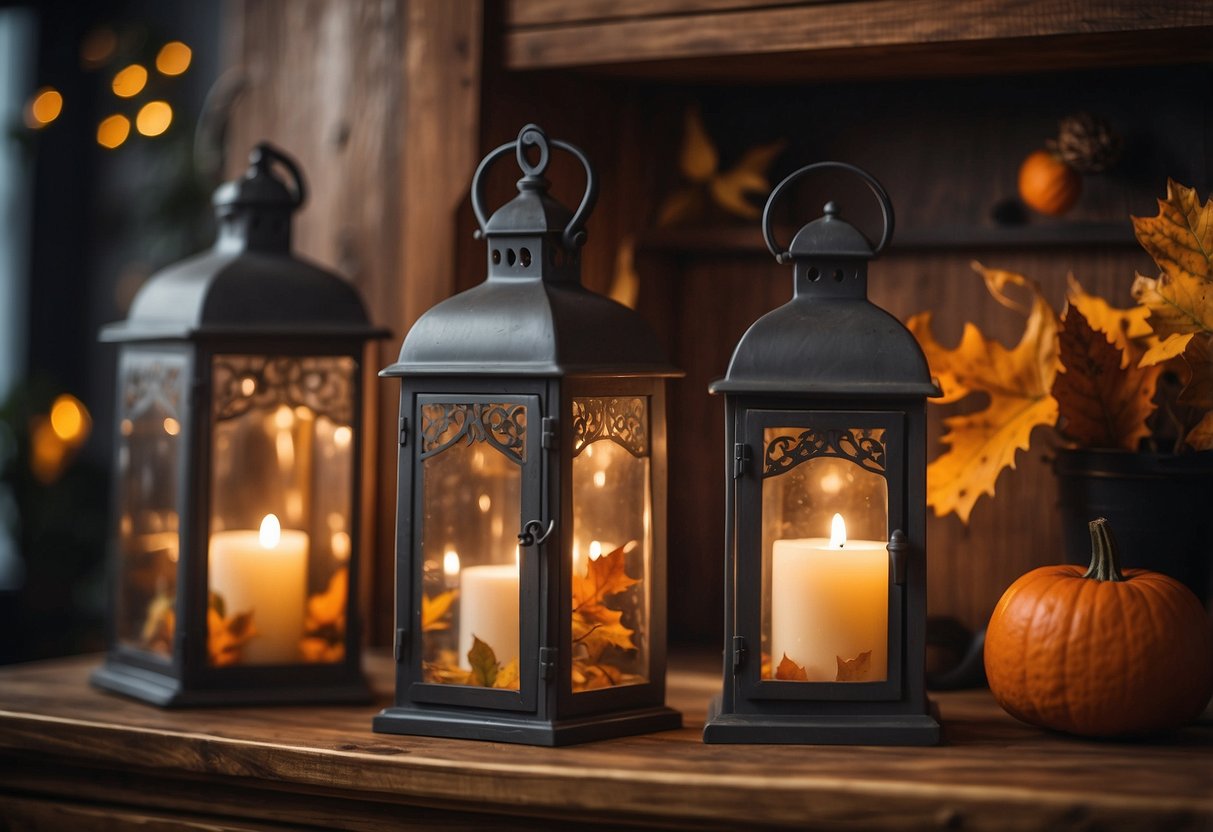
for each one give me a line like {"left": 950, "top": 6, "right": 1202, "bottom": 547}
{"left": 227, "top": 0, "right": 1213, "bottom": 645}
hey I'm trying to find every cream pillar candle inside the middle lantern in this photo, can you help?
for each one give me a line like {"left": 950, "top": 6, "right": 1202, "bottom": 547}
{"left": 459, "top": 563, "right": 519, "bottom": 669}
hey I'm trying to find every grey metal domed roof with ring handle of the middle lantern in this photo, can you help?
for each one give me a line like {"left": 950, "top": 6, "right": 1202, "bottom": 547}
{"left": 380, "top": 125, "right": 680, "bottom": 376}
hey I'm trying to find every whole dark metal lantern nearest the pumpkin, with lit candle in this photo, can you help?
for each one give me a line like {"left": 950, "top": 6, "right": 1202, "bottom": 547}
{"left": 704, "top": 163, "right": 939, "bottom": 745}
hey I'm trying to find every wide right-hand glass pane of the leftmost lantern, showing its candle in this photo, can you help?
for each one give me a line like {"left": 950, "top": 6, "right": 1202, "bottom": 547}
{"left": 207, "top": 355, "right": 357, "bottom": 666}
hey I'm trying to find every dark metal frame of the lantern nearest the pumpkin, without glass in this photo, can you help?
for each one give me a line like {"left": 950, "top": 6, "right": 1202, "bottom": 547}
{"left": 704, "top": 163, "right": 940, "bottom": 745}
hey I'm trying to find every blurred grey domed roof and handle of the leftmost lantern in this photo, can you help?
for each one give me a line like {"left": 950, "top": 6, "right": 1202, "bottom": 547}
{"left": 101, "top": 143, "right": 383, "bottom": 341}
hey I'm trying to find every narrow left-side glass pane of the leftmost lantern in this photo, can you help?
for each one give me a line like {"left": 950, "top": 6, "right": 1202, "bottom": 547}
{"left": 116, "top": 352, "right": 189, "bottom": 657}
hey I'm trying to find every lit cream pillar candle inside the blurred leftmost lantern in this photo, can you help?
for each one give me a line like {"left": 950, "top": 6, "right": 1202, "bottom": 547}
{"left": 209, "top": 514, "right": 308, "bottom": 665}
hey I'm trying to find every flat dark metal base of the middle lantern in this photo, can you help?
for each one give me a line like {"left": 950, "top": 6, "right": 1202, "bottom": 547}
{"left": 371, "top": 707, "right": 682, "bottom": 747}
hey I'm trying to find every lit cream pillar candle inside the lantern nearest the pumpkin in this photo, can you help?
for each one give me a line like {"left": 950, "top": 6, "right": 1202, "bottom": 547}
{"left": 770, "top": 514, "right": 889, "bottom": 682}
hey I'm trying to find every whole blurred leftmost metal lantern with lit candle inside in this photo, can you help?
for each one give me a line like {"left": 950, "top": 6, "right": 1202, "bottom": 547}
{"left": 92, "top": 144, "right": 382, "bottom": 706}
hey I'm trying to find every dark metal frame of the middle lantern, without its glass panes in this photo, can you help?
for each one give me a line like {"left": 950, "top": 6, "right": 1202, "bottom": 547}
{"left": 374, "top": 125, "right": 682, "bottom": 746}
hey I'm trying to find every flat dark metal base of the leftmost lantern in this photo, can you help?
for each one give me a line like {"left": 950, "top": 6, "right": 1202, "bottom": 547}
{"left": 89, "top": 662, "right": 375, "bottom": 708}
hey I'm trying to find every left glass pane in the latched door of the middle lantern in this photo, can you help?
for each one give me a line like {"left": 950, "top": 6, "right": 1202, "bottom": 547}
{"left": 421, "top": 401, "right": 526, "bottom": 690}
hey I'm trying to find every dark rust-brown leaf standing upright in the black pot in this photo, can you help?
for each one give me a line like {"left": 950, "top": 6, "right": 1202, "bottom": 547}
{"left": 1053, "top": 307, "right": 1162, "bottom": 451}
